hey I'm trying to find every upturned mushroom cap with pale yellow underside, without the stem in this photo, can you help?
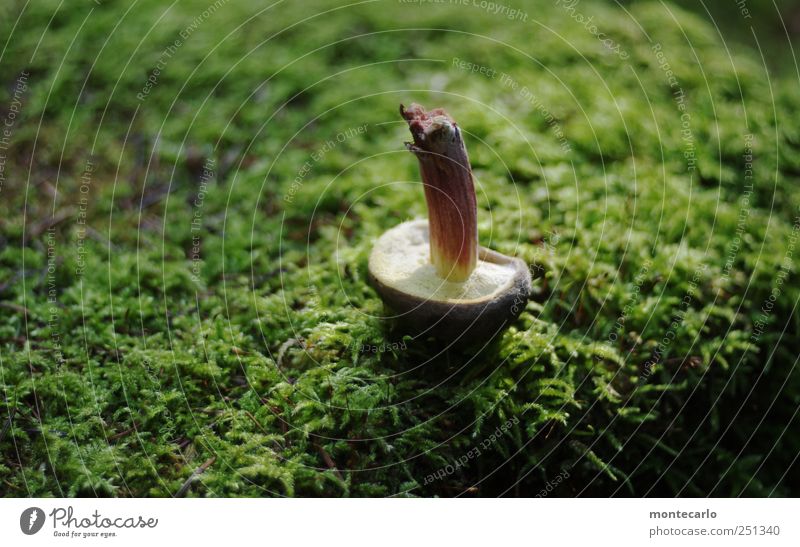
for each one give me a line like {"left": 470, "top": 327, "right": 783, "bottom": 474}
{"left": 369, "top": 220, "right": 531, "bottom": 341}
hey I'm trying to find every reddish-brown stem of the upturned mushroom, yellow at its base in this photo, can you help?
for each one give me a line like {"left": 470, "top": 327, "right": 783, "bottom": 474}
{"left": 400, "top": 104, "right": 478, "bottom": 282}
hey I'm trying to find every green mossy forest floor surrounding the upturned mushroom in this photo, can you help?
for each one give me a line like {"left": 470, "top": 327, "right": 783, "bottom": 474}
{"left": 0, "top": 0, "right": 800, "bottom": 496}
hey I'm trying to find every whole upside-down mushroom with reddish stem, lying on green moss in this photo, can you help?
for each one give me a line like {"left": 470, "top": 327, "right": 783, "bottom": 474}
{"left": 369, "top": 104, "right": 531, "bottom": 340}
